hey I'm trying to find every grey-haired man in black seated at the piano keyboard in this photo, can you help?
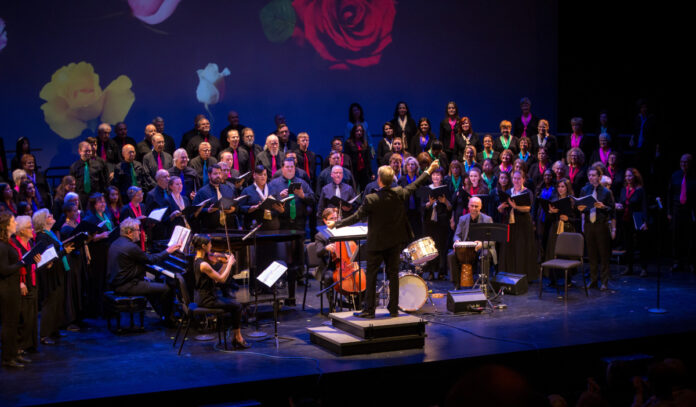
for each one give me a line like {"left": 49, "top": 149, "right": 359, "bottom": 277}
{"left": 107, "top": 218, "right": 181, "bottom": 325}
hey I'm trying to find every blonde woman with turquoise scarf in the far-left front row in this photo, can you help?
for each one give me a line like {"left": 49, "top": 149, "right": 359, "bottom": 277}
{"left": 31, "top": 209, "right": 75, "bottom": 345}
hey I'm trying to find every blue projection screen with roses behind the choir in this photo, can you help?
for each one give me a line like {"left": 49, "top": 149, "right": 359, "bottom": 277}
{"left": 0, "top": 0, "right": 557, "bottom": 169}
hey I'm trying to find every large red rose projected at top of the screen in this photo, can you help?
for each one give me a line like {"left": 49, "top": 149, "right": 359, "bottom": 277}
{"left": 292, "top": 0, "right": 396, "bottom": 69}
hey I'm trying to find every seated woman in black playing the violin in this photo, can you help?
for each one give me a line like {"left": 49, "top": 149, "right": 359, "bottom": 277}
{"left": 193, "top": 235, "right": 251, "bottom": 349}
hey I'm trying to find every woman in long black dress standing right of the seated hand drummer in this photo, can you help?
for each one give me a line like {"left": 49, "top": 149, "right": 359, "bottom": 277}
{"left": 498, "top": 171, "right": 538, "bottom": 281}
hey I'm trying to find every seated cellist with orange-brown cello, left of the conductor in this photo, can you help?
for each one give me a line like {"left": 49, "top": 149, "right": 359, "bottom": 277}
{"left": 314, "top": 208, "right": 367, "bottom": 312}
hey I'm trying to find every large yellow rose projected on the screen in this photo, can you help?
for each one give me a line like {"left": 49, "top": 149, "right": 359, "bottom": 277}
{"left": 39, "top": 62, "right": 135, "bottom": 139}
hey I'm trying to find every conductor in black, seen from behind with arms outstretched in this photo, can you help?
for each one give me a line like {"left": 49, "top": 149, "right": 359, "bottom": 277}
{"left": 326, "top": 160, "right": 440, "bottom": 318}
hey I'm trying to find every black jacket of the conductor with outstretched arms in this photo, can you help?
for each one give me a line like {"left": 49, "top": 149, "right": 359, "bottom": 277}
{"left": 336, "top": 173, "right": 430, "bottom": 251}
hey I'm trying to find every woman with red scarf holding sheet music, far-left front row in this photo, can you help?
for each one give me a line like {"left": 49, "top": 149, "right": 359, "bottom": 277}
{"left": 11, "top": 216, "right": 39, "bottom": 355}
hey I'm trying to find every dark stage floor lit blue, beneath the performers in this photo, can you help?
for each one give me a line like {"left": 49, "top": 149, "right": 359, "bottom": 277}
{"left": 0, "top": 267, "right": 696, "bottom": 406}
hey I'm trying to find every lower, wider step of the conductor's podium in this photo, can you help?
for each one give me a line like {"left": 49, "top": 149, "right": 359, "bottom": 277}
{"left": 307, "top": 326, "right": 425, "bottom": 356}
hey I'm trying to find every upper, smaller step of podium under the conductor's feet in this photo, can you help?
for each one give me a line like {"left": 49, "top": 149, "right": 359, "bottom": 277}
{"left": 329, "top": 308, "right": 426, "bottom": 339}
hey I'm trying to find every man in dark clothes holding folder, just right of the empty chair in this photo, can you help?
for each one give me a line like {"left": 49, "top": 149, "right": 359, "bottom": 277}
{"left": 578, "top": 169, "right": 614, "bottom": 291}
